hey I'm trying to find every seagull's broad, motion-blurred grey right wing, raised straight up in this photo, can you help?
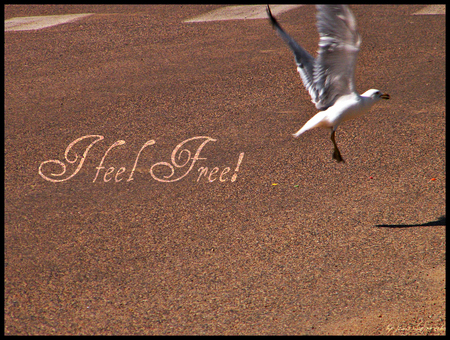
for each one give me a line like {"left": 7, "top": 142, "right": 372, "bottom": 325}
{"left": 314, "top": 5, "right": 361, "bottom": 109}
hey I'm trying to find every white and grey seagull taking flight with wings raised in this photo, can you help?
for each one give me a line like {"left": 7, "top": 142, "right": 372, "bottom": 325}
{"left": 267, "top": 5, "right": 390, "bottom": 163}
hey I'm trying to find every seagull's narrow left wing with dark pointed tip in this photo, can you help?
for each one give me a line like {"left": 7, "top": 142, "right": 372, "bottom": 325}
{"left": 267, "top": 5, "right": 318, "bottom": 107}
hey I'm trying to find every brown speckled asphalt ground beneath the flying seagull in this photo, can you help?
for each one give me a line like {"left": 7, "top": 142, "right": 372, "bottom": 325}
{"left": 4, "top": 5, "right": 446, "bottom": 335}
